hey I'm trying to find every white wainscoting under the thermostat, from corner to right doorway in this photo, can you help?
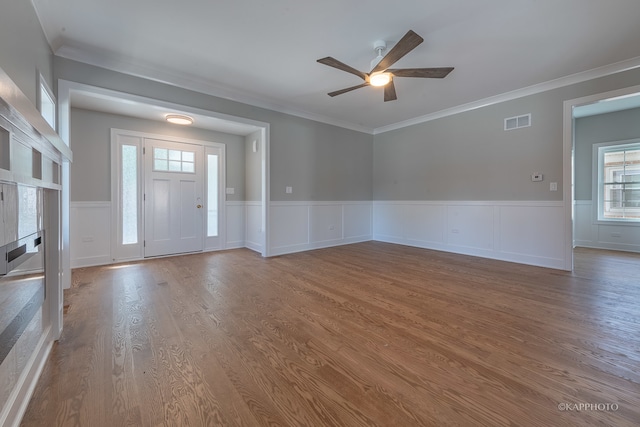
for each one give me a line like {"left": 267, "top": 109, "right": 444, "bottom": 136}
{"left": 373, "top": 201, "right": 565, "bottom": 269}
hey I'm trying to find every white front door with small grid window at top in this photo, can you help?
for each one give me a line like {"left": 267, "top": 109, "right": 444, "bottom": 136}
{"left": 144, "top": 138, "right": 205, "bottom": 257}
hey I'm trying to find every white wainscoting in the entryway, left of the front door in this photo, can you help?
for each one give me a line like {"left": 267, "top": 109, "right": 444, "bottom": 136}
{"left": 69, "top": 202, "right": 112, "bottom": 268}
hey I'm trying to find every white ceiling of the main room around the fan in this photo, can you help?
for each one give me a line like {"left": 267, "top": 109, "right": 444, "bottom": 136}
{"left": 32, "top": 0, "right": 640, "bottom": 131}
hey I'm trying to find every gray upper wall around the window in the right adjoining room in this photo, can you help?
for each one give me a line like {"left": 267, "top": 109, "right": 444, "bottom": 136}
{"left": 574, "top": 108, "right": 640, "bottom": 200}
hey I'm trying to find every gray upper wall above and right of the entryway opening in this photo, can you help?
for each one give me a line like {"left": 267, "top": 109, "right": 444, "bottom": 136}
{"left": 54, "top": 57, "right": 373, "bottom": 201}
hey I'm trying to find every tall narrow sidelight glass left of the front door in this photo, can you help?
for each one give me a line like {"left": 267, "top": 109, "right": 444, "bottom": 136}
{"left": 122, "top": 145, "right": 138, "bottom": 245}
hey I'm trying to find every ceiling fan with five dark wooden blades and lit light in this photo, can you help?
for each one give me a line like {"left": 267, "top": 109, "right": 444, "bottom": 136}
{"left": 318, "top": 30, "right": 453, "bottom": 102}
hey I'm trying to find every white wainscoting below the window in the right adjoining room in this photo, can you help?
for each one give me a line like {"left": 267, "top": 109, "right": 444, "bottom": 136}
{"left": 573, "top": 200, "right": 640, "bottom": 252}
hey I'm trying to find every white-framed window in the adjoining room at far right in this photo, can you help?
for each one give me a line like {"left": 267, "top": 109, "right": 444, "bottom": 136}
{"left": 594, "top": 140, "right": 640, "bottom": 222}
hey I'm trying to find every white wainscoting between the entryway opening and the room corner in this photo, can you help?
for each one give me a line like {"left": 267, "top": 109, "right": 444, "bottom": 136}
{"left": 269, "top": 201, "right": 373, "bottom": 255}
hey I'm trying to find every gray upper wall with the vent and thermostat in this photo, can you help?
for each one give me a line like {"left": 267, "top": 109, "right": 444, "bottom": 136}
{"left": 373, "top": 70, "right": 640, "bottom": 201}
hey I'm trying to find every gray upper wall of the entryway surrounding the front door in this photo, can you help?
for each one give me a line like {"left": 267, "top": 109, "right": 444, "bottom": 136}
{"left": 70, "top": 108, "right": 245, "bottom": 202}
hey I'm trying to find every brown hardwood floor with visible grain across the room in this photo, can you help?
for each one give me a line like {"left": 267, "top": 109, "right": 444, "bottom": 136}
{"left": 22, "top": 242, "right": 640, "bottom": 427}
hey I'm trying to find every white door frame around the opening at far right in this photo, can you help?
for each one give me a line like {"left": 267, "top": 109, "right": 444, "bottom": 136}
{"left": 562, "top": 85, "right": 640, "bottom": 271}
